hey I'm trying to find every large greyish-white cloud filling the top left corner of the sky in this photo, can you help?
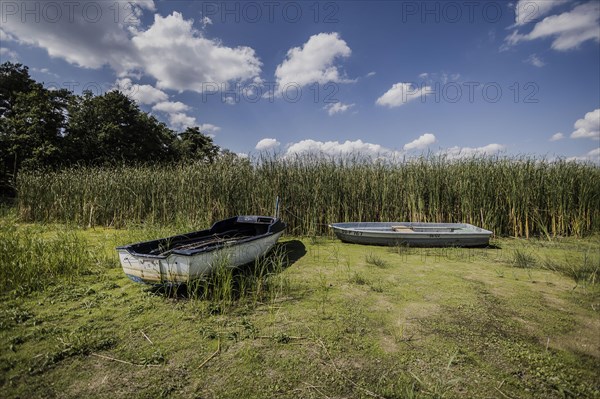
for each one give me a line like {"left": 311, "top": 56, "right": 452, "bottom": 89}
{"left": 0, "top": 0, "right": 155, "bottom": 76}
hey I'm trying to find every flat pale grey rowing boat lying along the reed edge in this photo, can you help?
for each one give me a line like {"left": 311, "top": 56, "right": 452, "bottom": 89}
{"left": 329, "top": 222, "right": 492, "bottom": 247}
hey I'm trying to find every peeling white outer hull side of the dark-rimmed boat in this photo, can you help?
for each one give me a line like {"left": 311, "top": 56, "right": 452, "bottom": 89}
{"left": 118, "top": 232, "right": 283, "bottom": 284}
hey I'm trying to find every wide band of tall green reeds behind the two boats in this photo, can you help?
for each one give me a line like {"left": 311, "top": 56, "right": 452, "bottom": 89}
{"left": 18, "top": 156, "right": 600, "bottom": 236}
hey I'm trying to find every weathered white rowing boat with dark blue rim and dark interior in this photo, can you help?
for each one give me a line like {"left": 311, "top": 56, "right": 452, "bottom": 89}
{"left": 117, "top": 216, "right": 285, "bottom": 284}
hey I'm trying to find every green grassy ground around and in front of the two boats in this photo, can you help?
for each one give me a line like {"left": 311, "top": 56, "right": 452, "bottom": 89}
{"left": 0, "top": 217, "right": 600, "bottom": 398}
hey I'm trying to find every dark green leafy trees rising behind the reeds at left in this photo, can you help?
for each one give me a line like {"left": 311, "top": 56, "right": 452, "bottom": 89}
{"left": 0, "top": 62, "right": 223, "bottom": 196}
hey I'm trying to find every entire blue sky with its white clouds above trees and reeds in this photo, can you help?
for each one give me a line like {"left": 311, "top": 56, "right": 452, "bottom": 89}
{"left": 0, "top": 0, "right": 600, "bottom": 162}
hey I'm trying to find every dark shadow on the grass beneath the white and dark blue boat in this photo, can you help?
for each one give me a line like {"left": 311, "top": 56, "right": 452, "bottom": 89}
{"left": 147, "top": 240, "right": 307, "bottom": 301}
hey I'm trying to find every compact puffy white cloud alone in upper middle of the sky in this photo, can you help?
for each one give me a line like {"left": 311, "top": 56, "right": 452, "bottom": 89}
{"left": 275, "top": 32, "right": 352, "bottom": 88}
